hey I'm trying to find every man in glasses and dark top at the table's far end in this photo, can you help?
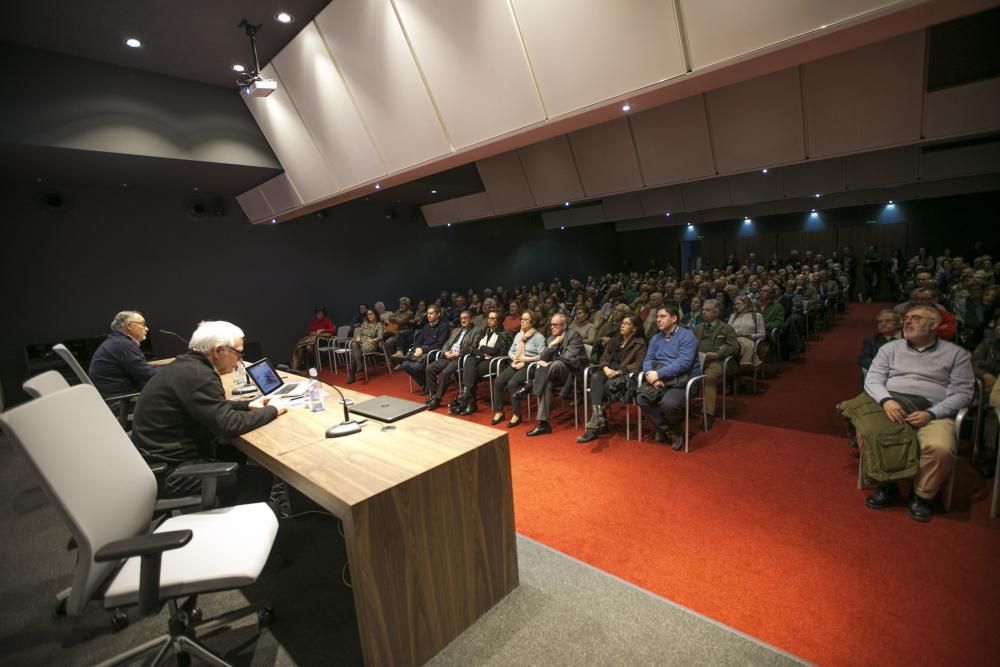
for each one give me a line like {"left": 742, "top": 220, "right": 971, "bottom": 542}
{"left": 88, "top": 310, "right": 159, "bottom": 398}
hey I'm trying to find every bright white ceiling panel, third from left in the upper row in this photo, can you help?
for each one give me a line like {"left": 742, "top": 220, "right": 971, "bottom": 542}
{"left": 316, "top": 0, "right": 451, "bottom": 172}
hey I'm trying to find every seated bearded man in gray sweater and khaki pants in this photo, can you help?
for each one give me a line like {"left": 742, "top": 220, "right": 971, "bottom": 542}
{"left": 865, "top": 306, "right": 974, "bottom": 522}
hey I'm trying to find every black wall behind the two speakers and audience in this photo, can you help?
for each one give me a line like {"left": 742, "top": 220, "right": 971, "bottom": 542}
{"left": 0, "top": 185, "right": 618, "bottom": 401}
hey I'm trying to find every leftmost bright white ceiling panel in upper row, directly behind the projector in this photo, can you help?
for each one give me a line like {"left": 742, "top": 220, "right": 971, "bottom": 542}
{"left": 242, "top": 65, "right": 337, "bottom": 210}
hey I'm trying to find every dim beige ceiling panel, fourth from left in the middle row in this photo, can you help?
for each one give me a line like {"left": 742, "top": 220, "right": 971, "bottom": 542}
{"left": 629, "top": 95, "right": 715, "bottom": 186}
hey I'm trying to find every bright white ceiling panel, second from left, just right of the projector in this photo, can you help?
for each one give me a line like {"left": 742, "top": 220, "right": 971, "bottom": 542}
{"left": 272, "top": 23, "right": 386, "bottom": 190}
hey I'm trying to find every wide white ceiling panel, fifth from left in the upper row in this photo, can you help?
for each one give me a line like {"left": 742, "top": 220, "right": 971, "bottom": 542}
{"left": 516, "top": 0, "right": 685, "bottom": 118}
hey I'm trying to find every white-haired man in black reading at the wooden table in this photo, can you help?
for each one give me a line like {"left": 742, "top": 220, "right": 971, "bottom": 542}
{"left": 132, "top": 321, "right": 284, "bottom": 495}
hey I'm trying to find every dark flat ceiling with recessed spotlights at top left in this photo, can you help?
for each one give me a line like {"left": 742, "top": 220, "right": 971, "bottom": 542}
{"left": 0, "top": 0, "right": 329, "bottom": 88}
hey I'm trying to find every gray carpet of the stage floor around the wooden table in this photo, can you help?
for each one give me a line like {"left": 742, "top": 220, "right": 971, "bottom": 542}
{"left": 0, "top": 437, "right": 799, "bottom": 667}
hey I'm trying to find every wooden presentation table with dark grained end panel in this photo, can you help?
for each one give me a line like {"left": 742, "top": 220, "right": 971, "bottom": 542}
{"left": 229, "top": 375, "right": 518, "bottom": 665}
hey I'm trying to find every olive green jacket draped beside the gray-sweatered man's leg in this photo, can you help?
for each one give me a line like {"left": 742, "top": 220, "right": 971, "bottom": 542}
{"left": 837, "top": 392, "right": 920, "bottom": 482}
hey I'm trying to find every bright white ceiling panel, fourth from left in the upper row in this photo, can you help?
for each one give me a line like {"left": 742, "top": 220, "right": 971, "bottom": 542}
{"left": 396, "top": 0, "right": 545, "bottom": 148}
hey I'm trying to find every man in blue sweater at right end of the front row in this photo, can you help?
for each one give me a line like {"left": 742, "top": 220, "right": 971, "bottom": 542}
{"left": 639, "top": 303, "right": 701, "bottom": 451}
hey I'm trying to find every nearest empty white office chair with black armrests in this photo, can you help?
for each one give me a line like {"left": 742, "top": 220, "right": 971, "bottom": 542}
{"left": 0, "top": 385, "right": 278, "bottom": 667}
